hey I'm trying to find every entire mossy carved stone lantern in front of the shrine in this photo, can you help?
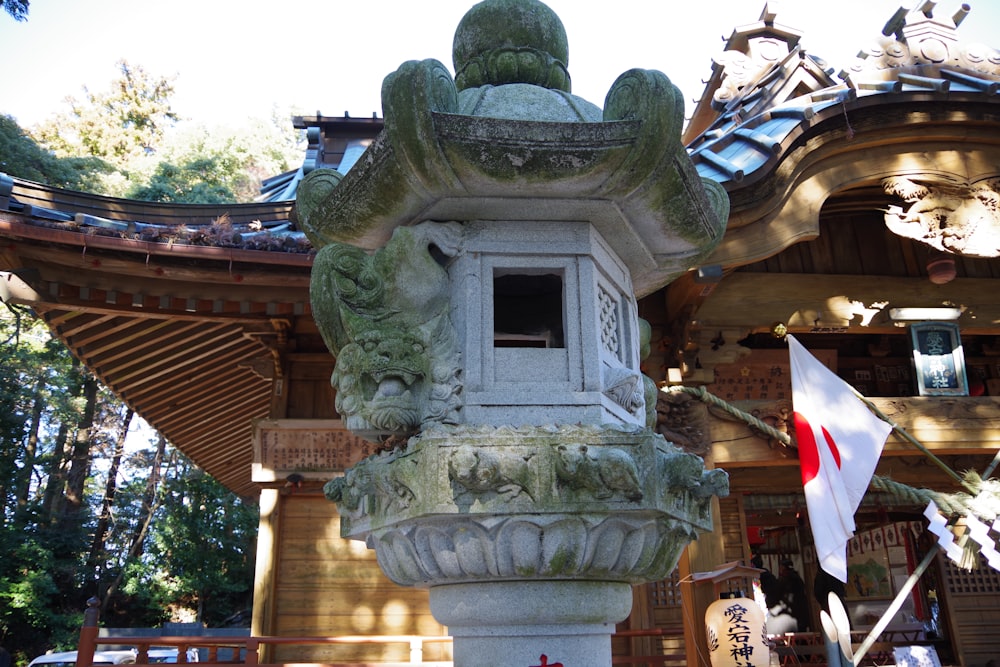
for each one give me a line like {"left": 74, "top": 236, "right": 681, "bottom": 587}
{"left": 296, "top": 0, "right": 728, "bottom": 667}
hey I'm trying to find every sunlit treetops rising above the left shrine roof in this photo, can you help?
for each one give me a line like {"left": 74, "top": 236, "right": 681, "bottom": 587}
{"left": 19, "top": 61, "right": 303, "bottom": 204}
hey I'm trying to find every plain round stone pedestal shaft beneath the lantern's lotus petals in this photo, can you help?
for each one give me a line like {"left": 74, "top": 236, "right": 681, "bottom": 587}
{"left": 430, "top": 581, "right": 632, "bottom": 667}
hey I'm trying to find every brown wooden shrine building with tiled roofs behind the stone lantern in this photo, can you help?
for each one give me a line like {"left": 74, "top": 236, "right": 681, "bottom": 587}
{"left": 0, "top": 3, "right": 1000, "bottom": 667}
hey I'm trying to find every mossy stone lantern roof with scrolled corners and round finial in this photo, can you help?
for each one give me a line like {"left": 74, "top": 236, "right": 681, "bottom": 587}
{"left": 297, "top": 0, "right": 729, "bottom": 296}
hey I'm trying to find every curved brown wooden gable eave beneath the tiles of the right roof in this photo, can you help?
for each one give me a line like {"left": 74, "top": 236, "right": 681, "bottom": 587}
{"left": 695, "top": 89, "right": 1000, "bottom": 267}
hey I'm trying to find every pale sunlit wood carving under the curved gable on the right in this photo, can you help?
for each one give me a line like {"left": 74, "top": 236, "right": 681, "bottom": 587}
{"left": 882, "top": 174, "right": 1000, "bottom": 257}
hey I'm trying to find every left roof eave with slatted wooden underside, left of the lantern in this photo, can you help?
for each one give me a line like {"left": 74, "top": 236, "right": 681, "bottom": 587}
{"left": 0, "top": 175, "right": 314, "bottom": 496}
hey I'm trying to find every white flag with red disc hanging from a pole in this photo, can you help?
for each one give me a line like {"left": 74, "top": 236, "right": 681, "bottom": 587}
{"left": 787, "top": 336, "right": 892, "bottom": 582}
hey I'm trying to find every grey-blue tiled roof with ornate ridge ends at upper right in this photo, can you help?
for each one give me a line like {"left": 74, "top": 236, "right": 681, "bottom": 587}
{"left": 687, "top": 6, "right": 1000, "bottom": 189}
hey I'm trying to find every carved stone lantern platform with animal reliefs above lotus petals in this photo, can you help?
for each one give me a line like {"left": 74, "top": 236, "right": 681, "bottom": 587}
{"left": 325, "top": 426, "right": 729, "bottom": 586}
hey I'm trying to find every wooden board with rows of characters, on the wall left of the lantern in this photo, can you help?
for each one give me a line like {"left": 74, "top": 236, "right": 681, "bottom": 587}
{"left": 253, "top": 419, "right": 374, "bottom": 482}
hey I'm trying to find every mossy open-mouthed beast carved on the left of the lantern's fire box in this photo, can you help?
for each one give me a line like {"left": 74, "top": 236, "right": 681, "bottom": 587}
{"left": 311, "top": 222, "right": 462, "bottom": 441}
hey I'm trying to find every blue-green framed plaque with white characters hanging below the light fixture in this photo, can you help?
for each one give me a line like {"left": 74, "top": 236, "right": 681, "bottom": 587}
{"left": 910, "top": 322, "right": 969, "bottom": 396}
